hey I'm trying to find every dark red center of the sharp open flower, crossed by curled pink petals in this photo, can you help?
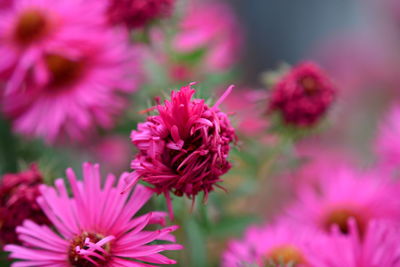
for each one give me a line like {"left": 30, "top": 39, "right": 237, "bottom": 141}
{"left": 68, "top": 232, "right": 114, "bottom": 267}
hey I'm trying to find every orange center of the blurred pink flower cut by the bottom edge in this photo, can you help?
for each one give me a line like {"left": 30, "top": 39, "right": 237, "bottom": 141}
{"left": 266, "top": 245, "right": 306, "bottom": 266}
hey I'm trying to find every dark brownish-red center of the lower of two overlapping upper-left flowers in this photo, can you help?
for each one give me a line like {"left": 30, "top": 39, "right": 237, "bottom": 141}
{"left": 45, "top": 54, "right": 83, "bottom": 87}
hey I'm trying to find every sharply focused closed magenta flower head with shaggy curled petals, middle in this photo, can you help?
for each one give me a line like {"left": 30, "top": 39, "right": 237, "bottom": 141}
{"left": 128, "top": 83, "right": 236, "bottom": 217}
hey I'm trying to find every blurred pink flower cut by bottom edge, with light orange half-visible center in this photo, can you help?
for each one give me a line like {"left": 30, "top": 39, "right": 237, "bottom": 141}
{"left": 222, "top": 221, "right": 325, "bottom": 267}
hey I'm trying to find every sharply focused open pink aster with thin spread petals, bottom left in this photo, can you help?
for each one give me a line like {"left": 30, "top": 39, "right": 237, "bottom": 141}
{"left": 5, "top": 163, "right": 181, "bottom": 267}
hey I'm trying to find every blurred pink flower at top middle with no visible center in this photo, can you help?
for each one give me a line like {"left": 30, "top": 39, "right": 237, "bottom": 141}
{"left": 173, "top": 1, "right": 242, "bottom": 71}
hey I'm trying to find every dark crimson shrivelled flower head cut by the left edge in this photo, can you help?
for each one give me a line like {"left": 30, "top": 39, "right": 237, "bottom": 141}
{"left": 0, "top": 164, "right": 49, "bottom": 248}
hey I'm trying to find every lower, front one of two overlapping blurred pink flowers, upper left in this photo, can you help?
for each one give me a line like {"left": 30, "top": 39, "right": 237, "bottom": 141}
{"left": 2, "top": 27, "right": 140, "bottom": 143}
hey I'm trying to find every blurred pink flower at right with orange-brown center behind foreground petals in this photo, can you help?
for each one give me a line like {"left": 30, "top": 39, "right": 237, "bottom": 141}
{"left": 288, "top": 167, "right": 400, "bottom": 239}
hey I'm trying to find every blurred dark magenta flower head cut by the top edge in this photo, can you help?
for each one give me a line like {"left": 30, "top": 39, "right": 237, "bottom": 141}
{"left": 108, "top": 0, "right": 175, "bottom": 28}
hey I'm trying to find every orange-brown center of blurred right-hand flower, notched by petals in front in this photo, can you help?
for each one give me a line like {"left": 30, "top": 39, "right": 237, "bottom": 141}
{"left": 324, "top": 209, "right": 366, "bottom": 235}
